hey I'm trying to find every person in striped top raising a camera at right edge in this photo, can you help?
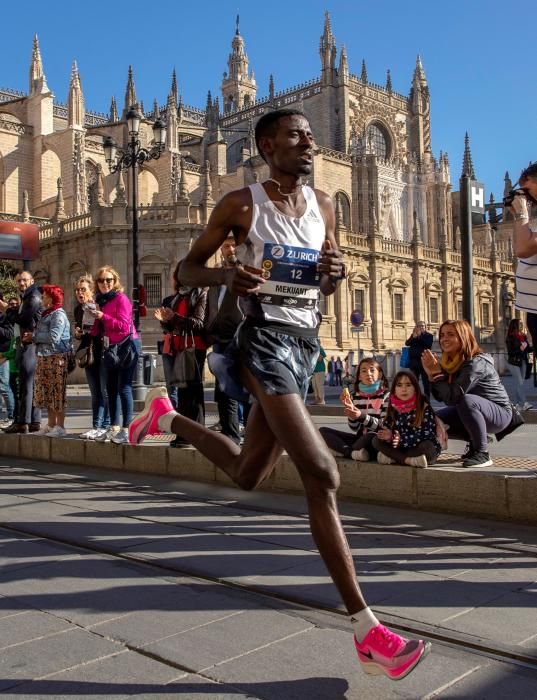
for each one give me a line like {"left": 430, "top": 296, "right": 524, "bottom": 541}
{"left": 504, "top": 163, "right": 537, "bottom": 347}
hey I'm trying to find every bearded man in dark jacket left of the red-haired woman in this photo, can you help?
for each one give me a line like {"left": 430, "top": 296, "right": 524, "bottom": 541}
{"left": 0, "top": 270, "right": 42, "bottom": 433}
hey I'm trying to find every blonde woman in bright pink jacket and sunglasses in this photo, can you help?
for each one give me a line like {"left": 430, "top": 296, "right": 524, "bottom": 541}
{"left": 90, "top": 265, "right": 141, "bottom": 443}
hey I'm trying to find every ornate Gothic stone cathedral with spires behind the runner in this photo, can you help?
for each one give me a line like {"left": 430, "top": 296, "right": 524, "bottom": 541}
{"left": 0, "top": 14, "right": 514, "bottom": 356}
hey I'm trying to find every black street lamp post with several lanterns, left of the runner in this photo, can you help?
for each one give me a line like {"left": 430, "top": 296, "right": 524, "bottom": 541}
{"left": 103, "top": 107, "right": 166, "bottom": 399}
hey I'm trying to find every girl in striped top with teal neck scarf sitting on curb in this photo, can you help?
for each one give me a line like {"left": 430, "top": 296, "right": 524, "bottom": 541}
{"left": 320, "top": 357, "right": 389, "bottom": 462}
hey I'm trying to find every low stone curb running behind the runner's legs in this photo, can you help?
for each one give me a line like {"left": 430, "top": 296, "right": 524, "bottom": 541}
{"left": 0, "top": 434, "right": 537, "bottom": 525}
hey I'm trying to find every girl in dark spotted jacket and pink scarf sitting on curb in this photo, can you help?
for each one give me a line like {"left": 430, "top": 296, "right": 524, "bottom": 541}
{"left": 373, "top": 370, "right": 441, "bottom": 468}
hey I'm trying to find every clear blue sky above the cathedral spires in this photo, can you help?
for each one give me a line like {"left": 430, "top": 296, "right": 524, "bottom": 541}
{"left": 0, "top": 0, "right": 537, "bottom": 199}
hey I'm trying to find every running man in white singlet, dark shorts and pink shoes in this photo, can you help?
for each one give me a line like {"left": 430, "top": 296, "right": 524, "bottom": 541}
{"left": 130, "top": 109, "right": 430, "bottom": 680}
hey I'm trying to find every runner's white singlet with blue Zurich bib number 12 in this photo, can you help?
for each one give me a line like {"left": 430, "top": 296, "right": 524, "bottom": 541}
{"left": 236, "top": 183, "right": 326, "bottom": 328}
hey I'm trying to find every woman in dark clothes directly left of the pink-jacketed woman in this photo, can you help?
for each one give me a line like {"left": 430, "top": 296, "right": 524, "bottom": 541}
{"left": 74, "top": 274, "right": 110, "bottom": 440}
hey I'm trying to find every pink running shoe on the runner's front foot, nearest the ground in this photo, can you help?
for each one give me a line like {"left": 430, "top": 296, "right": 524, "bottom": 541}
{"left": 354, "top": 625, "right": 431, "bottom": 681}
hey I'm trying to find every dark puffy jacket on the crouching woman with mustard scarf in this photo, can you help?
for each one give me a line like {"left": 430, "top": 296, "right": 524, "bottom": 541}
{"left": 431, "top": 352, "right": 511, "bottom": 407}
